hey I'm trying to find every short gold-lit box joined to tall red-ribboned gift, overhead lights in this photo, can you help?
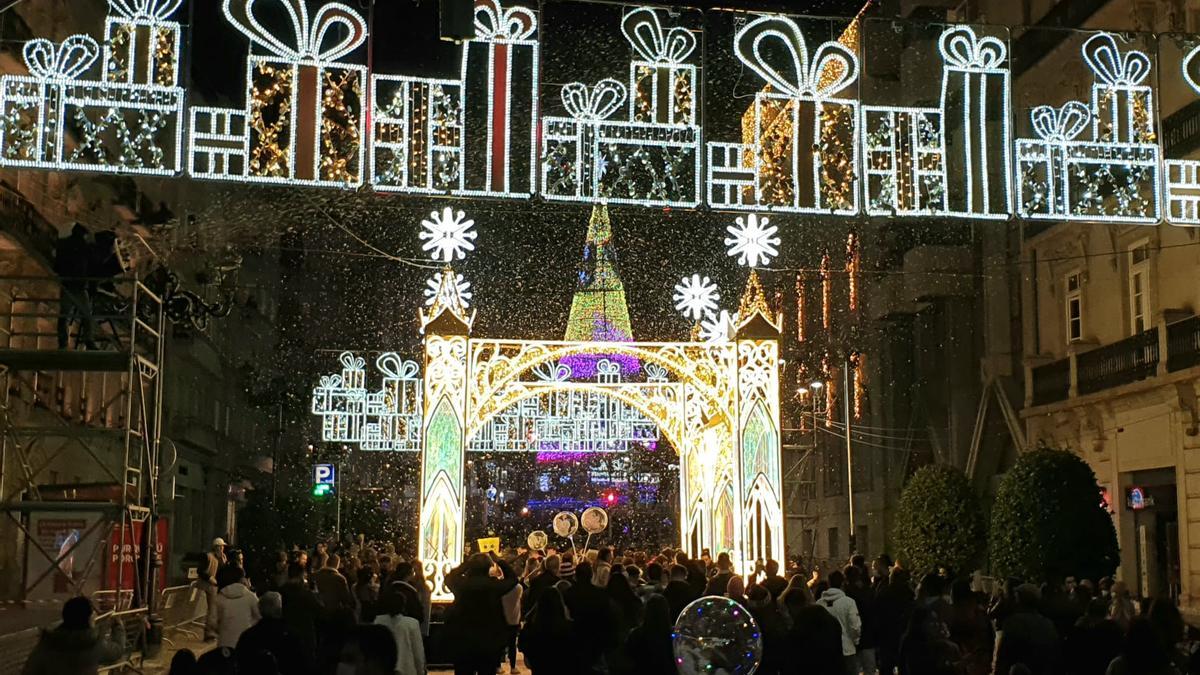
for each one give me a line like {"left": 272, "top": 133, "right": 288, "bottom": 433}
{"left": 370, "top": 0, "right": 541, "bottom": 197}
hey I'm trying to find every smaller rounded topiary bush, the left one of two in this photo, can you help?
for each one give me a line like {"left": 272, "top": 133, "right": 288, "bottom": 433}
{"left": 892, "top": 465, "right": 988, "bottom": 578}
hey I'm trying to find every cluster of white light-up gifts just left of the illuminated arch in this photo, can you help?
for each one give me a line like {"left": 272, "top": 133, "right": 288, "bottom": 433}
{"left": 311, "top": 352, "right": 421, "bottom": 452}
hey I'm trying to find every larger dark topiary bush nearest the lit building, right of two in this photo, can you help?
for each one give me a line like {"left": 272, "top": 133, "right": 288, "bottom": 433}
{"left": 990, "top": 448, "right": 1120, "bottom": 581}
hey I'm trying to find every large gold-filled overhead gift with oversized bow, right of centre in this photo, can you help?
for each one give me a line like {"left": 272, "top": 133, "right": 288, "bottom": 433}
{"left": 734, "top": 17, "right": 858, "bottom": 213}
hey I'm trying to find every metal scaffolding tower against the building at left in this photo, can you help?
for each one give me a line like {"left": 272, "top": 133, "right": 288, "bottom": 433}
{"left": 0, "top": 276, "right": 164, "bottom": 611}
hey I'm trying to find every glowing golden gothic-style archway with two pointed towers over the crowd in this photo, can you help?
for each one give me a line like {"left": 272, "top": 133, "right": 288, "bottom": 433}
{"left": 418, "top": 270, "right": 784, "bottom": 601}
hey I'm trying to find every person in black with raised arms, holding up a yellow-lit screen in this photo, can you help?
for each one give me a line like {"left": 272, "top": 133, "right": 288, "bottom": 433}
{"left": 446, "top": 554, "right": 517, "bottom": 675}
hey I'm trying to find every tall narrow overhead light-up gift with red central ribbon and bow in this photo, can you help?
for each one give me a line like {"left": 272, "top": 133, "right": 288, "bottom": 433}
{"left": 462, "top": 0, "right": 539, "bottom": 195}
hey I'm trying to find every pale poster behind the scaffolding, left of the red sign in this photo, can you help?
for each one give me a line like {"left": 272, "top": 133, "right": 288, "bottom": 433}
{"left": 25, "top": 512, "right": 104, "bottom": 601}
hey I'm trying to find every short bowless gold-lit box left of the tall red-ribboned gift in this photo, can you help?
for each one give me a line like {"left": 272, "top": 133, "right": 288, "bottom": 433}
{"left": 371, "top": 74, "right": 463, "bottom": 193}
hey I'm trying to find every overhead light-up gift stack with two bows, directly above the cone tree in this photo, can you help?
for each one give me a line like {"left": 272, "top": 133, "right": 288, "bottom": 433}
{"left": 541, "top": 7, "right": 702, "bottom": 207}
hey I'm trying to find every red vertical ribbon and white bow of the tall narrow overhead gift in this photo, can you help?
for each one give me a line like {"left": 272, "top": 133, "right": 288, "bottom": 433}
{"left": 474, "top": 0, "right": 538, "bottom": 192}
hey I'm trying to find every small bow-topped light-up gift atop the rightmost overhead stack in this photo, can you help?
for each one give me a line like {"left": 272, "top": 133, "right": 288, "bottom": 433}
{"left": 1082, "top": 32, "right": 1154, "bottom": 143}
